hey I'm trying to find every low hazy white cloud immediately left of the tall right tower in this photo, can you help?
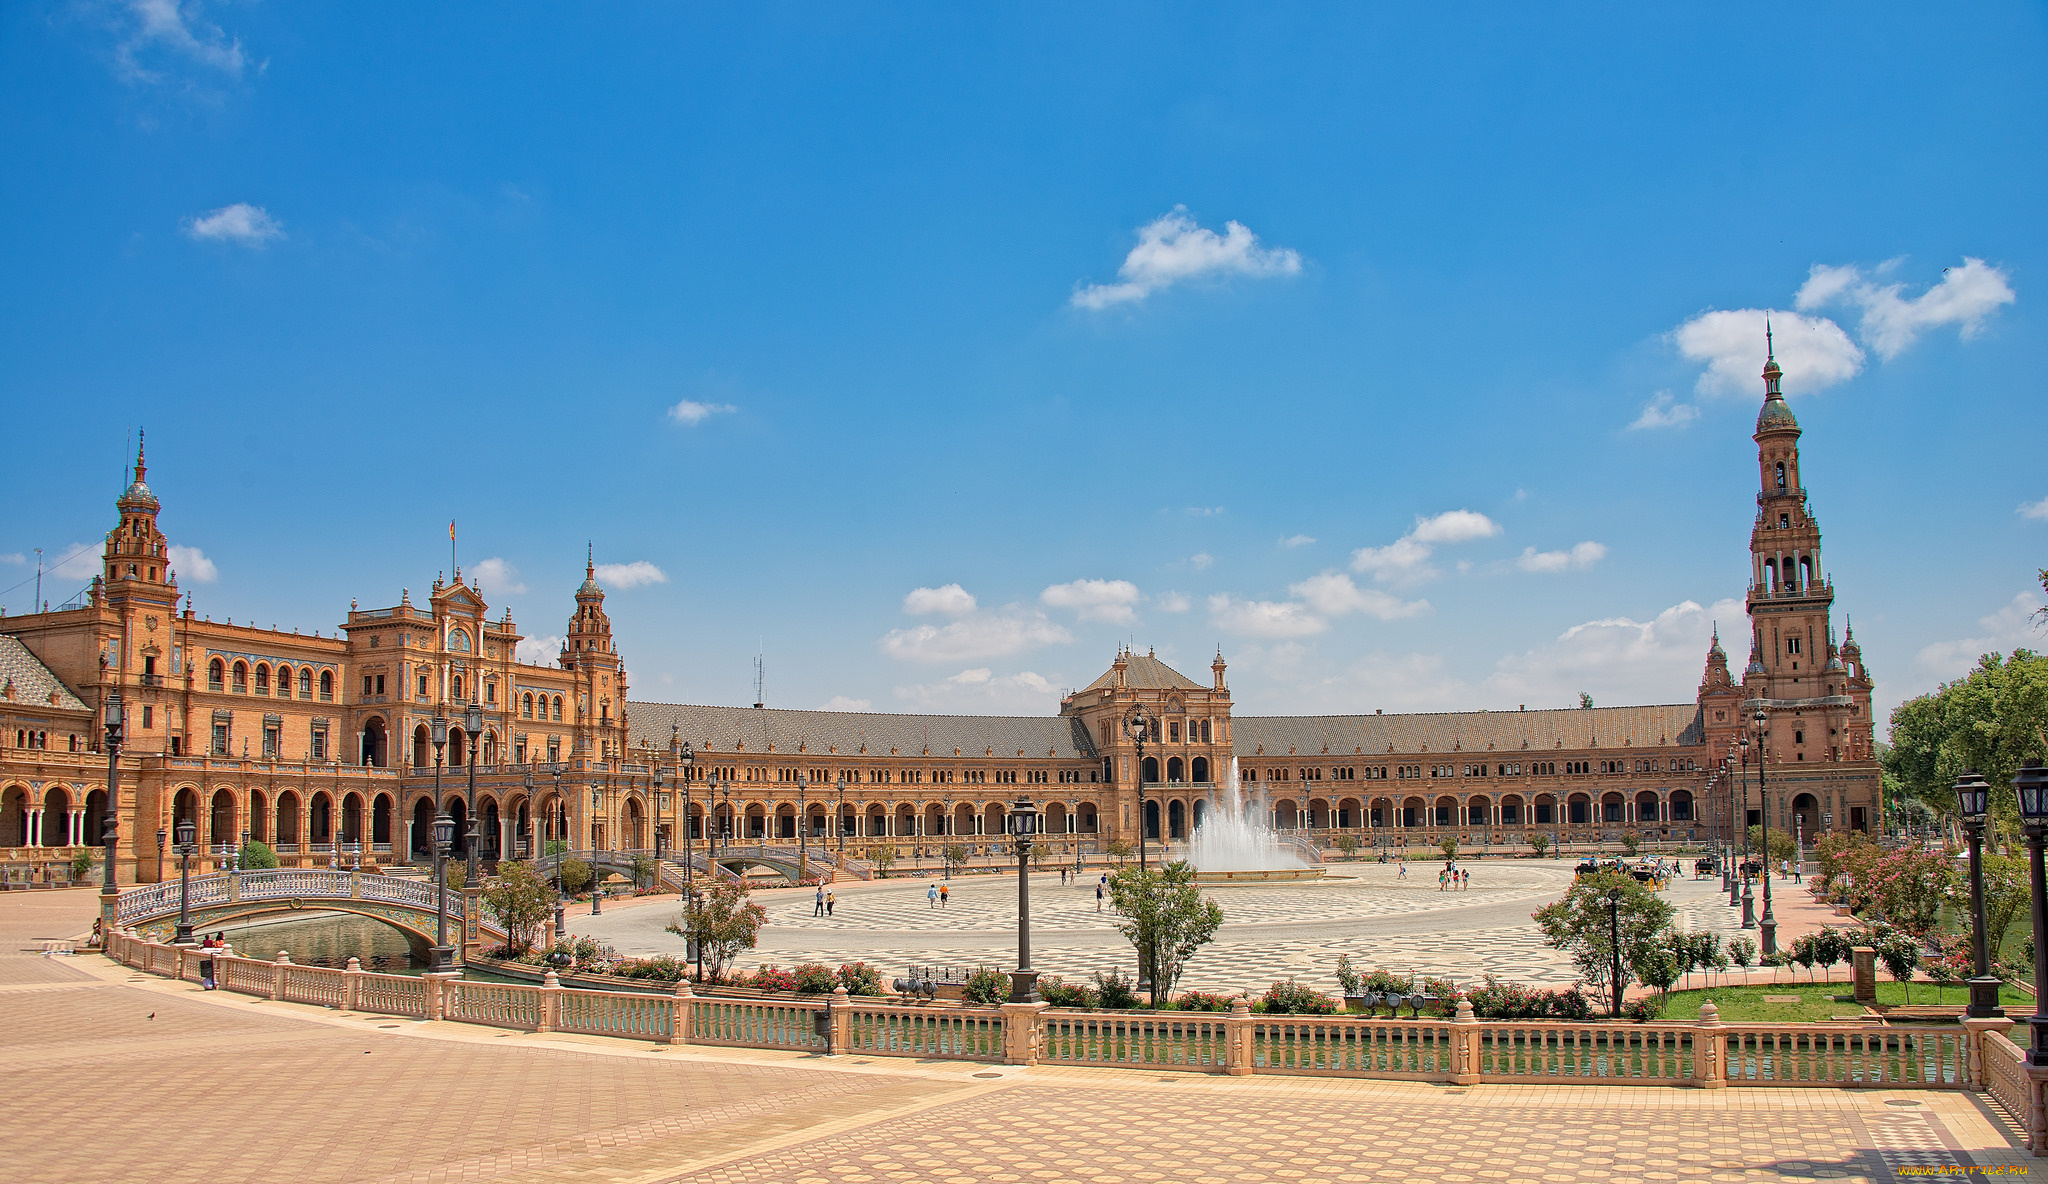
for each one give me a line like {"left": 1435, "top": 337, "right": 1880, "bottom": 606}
{"left": 1485, "top": 600, "right": 1747, "bottom": 707}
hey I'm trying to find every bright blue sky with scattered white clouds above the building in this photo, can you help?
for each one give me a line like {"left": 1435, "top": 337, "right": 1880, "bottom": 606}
{"left": 0, "top": 0, "right": 2048, "bottom": 713}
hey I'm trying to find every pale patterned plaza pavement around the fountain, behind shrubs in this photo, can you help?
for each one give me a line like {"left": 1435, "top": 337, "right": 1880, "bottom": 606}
{"left": 567, "top": 858, "right": 1837, "bottom": 993}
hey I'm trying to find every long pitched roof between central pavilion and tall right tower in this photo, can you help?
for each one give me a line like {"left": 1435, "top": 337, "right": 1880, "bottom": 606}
{"left": 1231, "top": 703, "right": 1706, "bottom": 758}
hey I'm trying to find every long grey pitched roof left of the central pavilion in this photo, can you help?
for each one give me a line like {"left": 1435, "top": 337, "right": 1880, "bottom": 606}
{"left": 627, "top": 703, "right": 1096, "bottom": 758}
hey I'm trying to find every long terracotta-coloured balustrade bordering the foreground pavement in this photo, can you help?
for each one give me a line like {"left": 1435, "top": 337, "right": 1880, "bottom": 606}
{"left": 106, "top": 930, "right": 2048, "bottom": 1097}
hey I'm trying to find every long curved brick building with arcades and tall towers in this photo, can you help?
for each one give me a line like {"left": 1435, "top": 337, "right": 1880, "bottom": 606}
{"left": 0, "top": 346, "right": 1882, "bottom": 881}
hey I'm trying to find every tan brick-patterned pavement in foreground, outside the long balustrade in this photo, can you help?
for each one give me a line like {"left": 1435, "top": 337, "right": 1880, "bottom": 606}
{"left": 12, "top": 891, "right": 2034, "bottom": 1184}
